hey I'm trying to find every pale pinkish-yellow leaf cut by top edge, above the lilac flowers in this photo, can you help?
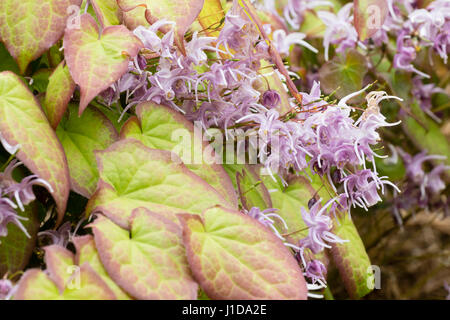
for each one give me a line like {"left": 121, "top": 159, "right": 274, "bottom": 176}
{"left": 117, "top": 0, "right": 204, "bottom": 50}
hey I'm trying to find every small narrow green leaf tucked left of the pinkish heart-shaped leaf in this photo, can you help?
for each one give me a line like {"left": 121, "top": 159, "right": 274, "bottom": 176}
{"left": 43, "top": 61, "right": 75, "bottom": 129}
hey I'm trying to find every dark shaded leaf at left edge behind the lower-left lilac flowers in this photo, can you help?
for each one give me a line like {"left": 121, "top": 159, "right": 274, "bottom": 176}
{"left": 0, "top": 203, "right": 39, "bottom": 278}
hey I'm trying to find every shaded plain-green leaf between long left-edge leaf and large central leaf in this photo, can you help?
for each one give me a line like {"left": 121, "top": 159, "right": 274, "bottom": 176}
{"left": 56, "top": 104, "right": 118, "bottom": 198}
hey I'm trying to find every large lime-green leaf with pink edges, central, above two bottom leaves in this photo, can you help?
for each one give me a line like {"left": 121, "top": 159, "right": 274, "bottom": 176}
{"left": 86, "top": 139, "right": 232, "bottom": 228}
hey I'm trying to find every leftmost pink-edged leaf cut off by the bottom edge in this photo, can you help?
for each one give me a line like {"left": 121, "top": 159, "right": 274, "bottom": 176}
{"left": 14, "top": 245, "right": 116, "bottom": 300}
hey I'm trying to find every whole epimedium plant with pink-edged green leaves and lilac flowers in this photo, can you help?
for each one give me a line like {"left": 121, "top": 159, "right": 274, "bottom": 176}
{"left": 0, "top": 0, "right": 450, "bottom": 299}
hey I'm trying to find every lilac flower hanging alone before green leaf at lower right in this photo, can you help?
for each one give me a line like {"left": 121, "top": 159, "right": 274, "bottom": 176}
{"left": 300, "top": 199, "right": 348, "bottom": 253}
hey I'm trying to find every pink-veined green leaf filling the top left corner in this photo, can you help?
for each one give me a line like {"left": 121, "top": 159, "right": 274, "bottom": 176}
{"left": 0, "top": 0, "right": 81, "bottom": 73}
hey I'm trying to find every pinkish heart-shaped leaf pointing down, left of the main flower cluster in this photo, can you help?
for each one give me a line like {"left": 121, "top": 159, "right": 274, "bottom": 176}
{"left": 64, "top": 14, "right": 143, "bottom": 114}
